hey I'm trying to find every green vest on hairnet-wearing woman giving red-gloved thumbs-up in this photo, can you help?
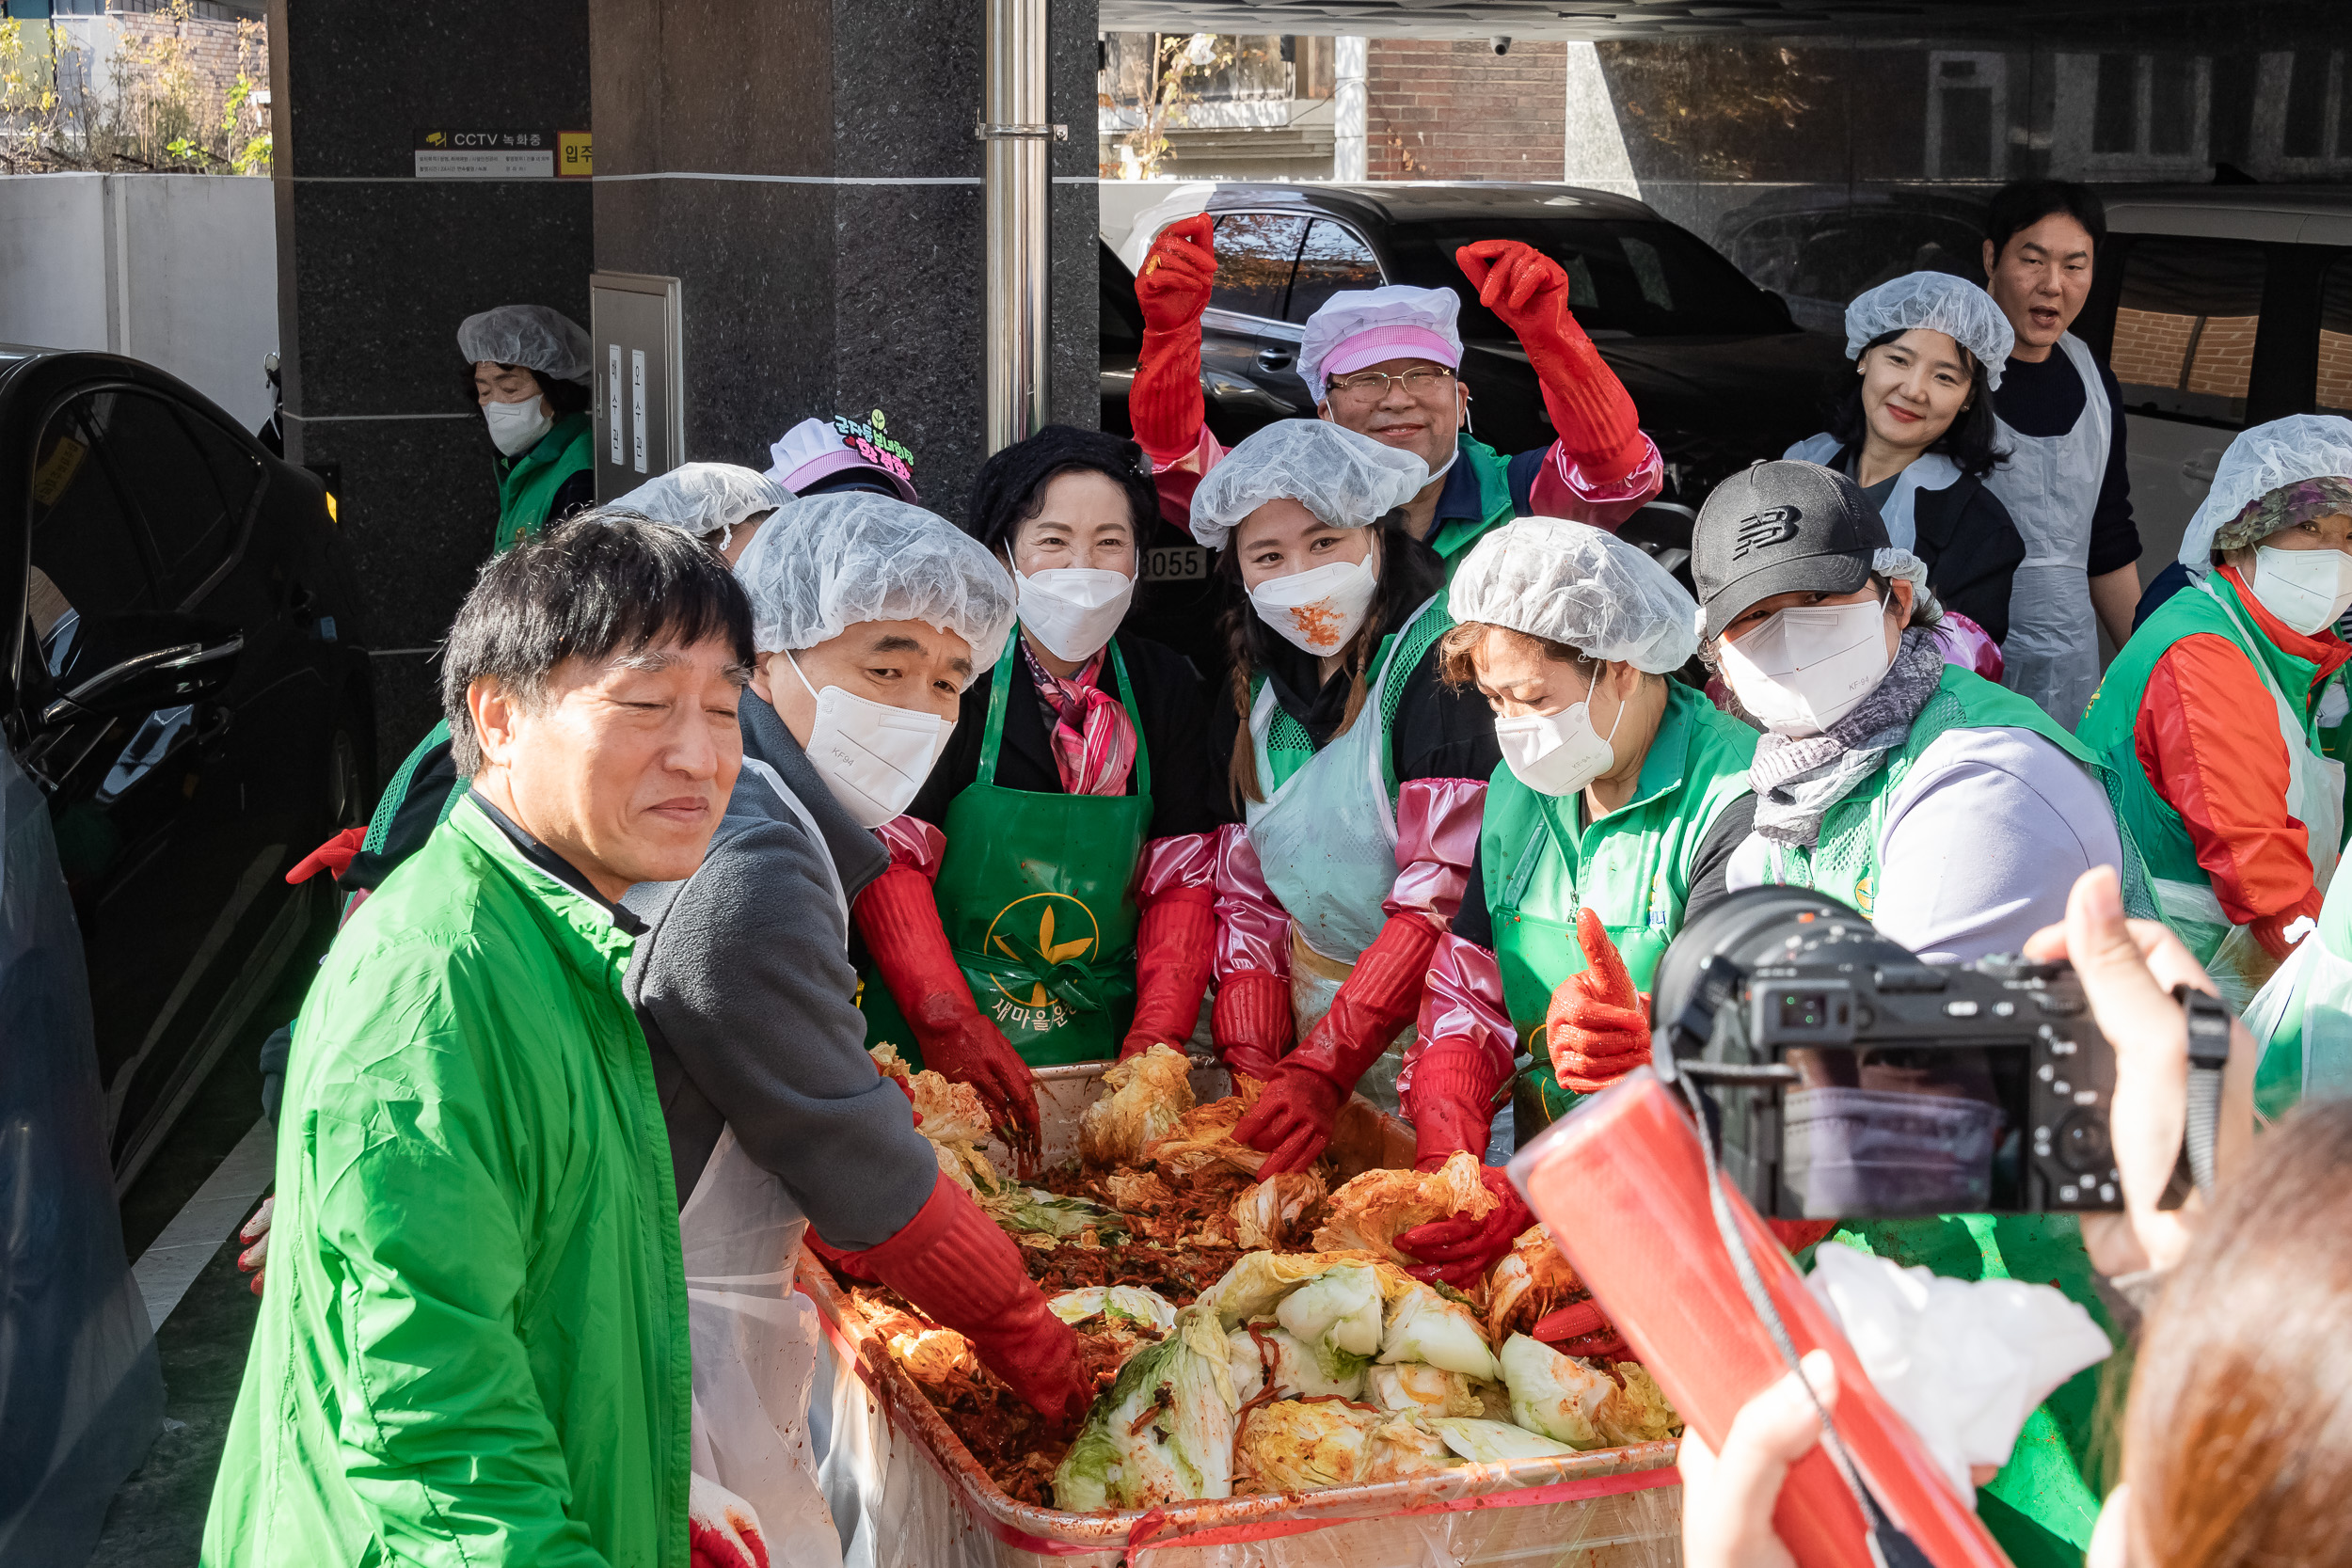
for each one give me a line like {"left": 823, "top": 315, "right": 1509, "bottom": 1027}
{"left": 1480, "top": 679, "right": 1757, "bottom": 1145}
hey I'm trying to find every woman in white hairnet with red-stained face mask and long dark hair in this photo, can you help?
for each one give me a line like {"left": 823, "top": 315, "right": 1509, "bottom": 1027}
{"left": 1193, "top": 419, "right": 1501, "bottom": 1173}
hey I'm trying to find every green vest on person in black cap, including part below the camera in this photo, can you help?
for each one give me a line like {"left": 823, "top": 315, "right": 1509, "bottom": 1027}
{"left": 1767, "top": 665, "right": 2153, "bottom": 1568}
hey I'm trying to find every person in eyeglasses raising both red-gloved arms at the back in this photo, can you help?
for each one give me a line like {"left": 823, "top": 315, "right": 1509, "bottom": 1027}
{"left": 1127, "top": 214, "right": 1665, "bottom": 566}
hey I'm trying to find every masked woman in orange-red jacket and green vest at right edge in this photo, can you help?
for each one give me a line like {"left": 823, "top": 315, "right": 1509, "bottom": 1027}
{"left": 2079, "top": 414, "right": 2352, "bottom": 1008}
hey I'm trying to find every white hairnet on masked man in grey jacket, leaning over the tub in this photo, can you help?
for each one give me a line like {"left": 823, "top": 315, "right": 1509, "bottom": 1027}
{"left": 737, "top": 491, "right": 1014, "bottom": 665}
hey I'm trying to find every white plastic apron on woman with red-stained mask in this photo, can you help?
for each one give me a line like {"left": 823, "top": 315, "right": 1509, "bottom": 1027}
{"left": 1247, "top": 594, "right": 1438, "bottom": 1110}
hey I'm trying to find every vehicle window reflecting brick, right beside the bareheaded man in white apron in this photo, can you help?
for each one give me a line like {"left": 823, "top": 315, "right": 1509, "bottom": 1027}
{"left": 2107, "top": 235, "right": 2265, "bottom": 423}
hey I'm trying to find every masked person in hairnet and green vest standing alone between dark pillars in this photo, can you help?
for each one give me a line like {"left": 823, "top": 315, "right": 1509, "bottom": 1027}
{"left": 456, "top": 306, "right": 596, "bottom": 550}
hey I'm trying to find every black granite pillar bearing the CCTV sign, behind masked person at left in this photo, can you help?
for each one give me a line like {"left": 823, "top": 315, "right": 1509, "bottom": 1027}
{"left": 271, "top": 0, "right": 593, "bottom": 773}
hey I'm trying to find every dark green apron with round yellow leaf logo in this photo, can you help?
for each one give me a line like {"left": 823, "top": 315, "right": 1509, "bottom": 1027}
{"left": 859, "top": 626, "right": 1152, "bottom": 1068}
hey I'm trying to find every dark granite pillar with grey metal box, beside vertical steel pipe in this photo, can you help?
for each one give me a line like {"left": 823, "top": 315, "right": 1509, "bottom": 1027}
{"left": 593, "top": 0, "right": 1099, "bottom": 517}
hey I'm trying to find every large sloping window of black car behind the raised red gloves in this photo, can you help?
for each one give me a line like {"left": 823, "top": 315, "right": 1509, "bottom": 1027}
{"left": 1388, "top": 218, "right": 1790, "bottom": 339}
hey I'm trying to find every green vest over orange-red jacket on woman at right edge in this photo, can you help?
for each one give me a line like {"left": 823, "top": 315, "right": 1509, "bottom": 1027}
{"left": 2079, "top": 571, "right": 2345, "bottom": 966}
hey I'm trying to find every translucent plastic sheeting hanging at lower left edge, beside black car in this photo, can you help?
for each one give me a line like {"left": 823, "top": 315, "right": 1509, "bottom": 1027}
{"left": 0, "top": 748, "right": 163, "bottom": 1568}
